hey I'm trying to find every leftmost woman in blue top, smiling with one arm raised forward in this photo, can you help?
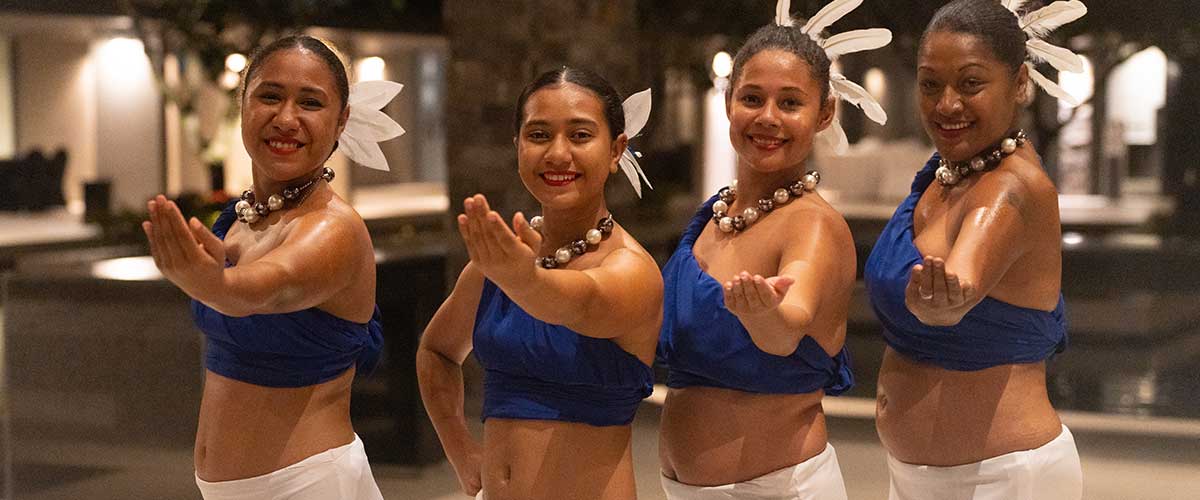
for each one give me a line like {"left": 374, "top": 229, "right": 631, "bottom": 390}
{"left": 143, "top": 36, "right": 382, "bottom": 500}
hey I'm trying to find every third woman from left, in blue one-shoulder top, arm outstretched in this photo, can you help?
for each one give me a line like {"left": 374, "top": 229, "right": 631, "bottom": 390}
{"left": 659, "top": 2, "right": 890, "bottom": 500}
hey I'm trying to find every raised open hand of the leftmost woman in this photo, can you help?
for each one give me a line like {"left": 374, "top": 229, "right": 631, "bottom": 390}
{"left": 142, "top": 194, "right": 226, "bottom": 301}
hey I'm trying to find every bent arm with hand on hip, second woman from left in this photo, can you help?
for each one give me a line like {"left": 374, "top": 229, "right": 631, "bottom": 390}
{"left": 416, "top": 264, "right": 484, "bottom": 495}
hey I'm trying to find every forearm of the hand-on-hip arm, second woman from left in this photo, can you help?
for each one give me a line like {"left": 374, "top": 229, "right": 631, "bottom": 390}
{"left": 416, "top": 348, "right": 474, "bottom": 462}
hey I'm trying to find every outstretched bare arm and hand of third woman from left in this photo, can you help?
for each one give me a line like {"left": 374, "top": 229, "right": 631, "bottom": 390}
{"left": 725, "top": 215, "right": 854, "bottom": 356}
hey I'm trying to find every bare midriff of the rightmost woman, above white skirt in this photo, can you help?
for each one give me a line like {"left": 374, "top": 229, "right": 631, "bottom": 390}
{"left": 875, "top": 348, "right": 1062, "bottom": 466}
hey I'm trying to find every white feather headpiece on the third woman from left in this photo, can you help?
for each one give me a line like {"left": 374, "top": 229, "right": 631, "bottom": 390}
{"left": 775, "top": 0, "right": 892, "bottom": 155}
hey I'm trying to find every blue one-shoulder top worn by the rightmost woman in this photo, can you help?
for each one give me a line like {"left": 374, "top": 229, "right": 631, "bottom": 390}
{"left": 864, "top": 153, "right": 1067, "bottom": 371}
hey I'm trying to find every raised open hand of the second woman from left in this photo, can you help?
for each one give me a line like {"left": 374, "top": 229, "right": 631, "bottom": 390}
{"left": 458, "top": 194, "right": 541, "bottom": 289}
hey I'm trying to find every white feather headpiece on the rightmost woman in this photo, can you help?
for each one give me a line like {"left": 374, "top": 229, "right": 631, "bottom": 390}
{"left": 1003, "top": 0, "right": 1087, "bottom": 106}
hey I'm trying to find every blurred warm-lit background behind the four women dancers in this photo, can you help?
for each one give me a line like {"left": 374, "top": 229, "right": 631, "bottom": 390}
{"left": 0, "top": 0, "right": 1200, "bottom": 499}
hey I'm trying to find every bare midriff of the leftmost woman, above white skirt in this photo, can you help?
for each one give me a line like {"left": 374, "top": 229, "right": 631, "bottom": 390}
{"left": 196, "top": 368, "right": 354, "bottom": 482}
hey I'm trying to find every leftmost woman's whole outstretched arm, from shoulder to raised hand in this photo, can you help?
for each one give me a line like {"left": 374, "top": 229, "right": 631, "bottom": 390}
{"left": 143, "top": 195, "right": 368, "bottom": 317}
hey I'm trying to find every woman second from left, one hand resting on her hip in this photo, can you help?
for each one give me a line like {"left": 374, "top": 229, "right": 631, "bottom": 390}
{"left": 416, "top": 67, "right": 662, "bottom": 500}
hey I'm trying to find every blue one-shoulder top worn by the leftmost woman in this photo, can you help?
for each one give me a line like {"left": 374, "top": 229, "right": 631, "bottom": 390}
{"left": 192, "top": 203, "right": 383, "bottom": 387}
